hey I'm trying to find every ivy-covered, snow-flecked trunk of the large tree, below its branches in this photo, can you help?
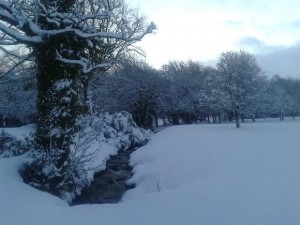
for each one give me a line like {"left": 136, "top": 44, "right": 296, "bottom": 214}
{"left": 35, "top": 36, "right": 83, "bottom": 172}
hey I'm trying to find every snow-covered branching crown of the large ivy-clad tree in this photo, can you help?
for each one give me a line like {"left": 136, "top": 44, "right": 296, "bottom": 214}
{"left": 0, "top": 0, "right": 156, "bottom": 73}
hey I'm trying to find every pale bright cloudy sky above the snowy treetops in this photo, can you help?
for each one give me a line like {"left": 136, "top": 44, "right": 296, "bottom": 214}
{"left": 127, "top": 0, "right": 300, "bottom": 78}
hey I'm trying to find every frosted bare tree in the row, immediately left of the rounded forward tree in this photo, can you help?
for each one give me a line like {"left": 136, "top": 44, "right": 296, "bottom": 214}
{"left": 162, "top": 60, "right": 211, "bottom": 123}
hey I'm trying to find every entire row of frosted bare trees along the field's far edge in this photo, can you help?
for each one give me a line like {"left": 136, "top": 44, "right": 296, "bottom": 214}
{"left": 91, "top": 51, "right": 300, "bottom": 128}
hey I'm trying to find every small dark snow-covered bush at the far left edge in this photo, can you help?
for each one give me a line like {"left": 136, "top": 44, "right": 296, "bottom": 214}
{"left": 0, "top": 130, "right": 31, "bottom": 158}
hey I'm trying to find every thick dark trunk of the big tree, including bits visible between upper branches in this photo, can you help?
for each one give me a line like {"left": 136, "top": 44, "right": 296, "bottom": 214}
{"left": 33, "top": 0, "right": 86, "bottom": 173}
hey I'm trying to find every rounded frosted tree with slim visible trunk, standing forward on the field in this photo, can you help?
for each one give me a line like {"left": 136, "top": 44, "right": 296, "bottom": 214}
{"left": 217, "top": 51, "right": 264, "bottom": 128}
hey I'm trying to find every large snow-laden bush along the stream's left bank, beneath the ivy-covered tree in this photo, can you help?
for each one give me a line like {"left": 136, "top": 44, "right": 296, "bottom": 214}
{"left": 20, "top": 112, "right": 151, "bottom": 202}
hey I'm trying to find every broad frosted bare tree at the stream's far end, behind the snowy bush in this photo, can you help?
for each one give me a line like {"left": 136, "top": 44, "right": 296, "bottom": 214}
{"left": 93, "top": 58, "right": 163, "bottom": 129}
